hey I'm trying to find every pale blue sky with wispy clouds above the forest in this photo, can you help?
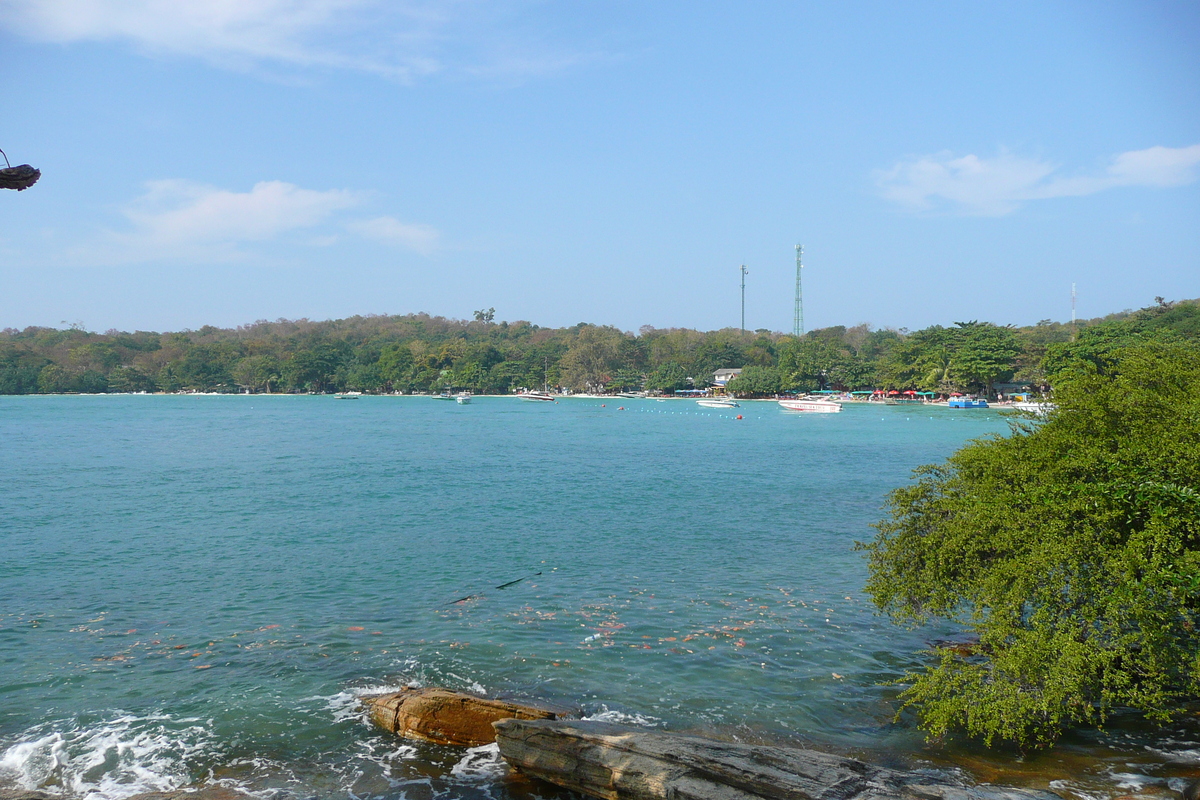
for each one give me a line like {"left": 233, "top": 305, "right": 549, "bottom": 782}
{"left": 0, "top": 0, "right": 1200, "bottom": 332}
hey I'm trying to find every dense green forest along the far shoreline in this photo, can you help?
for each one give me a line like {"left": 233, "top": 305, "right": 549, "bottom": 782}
{"left": 0, "top": 299, "right": 1200, "bottom": 396}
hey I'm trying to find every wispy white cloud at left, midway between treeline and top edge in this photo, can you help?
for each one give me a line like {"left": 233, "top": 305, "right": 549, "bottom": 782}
{"left": 77, "top": 180, "right": 439, "bottom": 264}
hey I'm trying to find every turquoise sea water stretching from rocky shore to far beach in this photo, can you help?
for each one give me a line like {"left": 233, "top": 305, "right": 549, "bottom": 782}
{"left": 0, "top": 395, "right": 1200, "bottom": 800}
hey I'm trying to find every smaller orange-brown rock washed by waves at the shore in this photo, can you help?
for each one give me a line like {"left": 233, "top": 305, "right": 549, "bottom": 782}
{"left": 362, "top": 688, "right": 575, "bottom": 747}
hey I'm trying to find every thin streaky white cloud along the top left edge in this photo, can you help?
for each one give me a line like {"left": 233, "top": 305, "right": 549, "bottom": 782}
{"left": 0, "top": 0, "right": 595, "bottom": 82}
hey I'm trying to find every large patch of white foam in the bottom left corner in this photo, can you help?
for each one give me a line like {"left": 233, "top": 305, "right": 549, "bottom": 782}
{"left": 0, "top": 715, "right": 214, "bottom": 800}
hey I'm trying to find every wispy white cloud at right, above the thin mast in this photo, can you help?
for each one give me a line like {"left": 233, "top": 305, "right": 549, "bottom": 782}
{"left": 876, "top": 144, "right": 1200, "bottom": 216}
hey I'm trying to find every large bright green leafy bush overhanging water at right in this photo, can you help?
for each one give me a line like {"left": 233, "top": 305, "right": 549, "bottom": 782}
{"left": 860, "top": 342, "right": 1200, "bottom": 746}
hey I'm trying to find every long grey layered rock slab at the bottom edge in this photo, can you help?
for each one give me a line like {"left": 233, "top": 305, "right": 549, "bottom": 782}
{"left": 494, "top": 720, "right": 1061, "bottom": 800}
